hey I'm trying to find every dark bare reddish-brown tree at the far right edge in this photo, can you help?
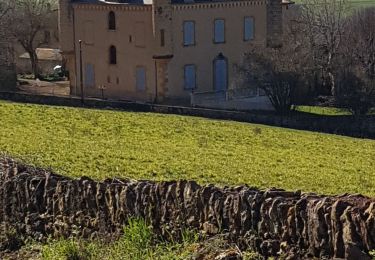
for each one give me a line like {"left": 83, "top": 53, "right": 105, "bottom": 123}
{"left": 335, "top": 8, "right": 375, "bottom": 116}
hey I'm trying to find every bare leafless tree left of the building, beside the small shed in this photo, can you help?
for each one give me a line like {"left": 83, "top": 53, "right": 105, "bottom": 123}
{"left": 6, "top": 0, "right": 57, "bottom": 78}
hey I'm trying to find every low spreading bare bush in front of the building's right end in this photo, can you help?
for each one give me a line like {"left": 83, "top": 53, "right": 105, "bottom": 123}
{"left": 238, "top": 45, "right": 305, "bottom": 114}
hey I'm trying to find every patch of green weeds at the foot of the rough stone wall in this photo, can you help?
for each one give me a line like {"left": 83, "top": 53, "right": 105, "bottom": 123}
{"left": 41, "top": 218, "right": 198, "bottom": 260}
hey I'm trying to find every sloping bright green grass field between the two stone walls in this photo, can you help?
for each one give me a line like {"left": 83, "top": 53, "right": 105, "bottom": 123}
{"left": 0, "top": 101, "right": 375, "bottom": 196}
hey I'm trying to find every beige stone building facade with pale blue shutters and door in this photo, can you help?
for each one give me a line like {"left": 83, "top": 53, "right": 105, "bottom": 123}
{"left": 59, "top": 0, "right": 290, "bottom": 102}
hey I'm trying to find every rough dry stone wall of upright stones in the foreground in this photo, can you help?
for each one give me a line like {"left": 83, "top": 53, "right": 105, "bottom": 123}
{"left": 0, "top": 159, "right": 375, "bottom": 259}
